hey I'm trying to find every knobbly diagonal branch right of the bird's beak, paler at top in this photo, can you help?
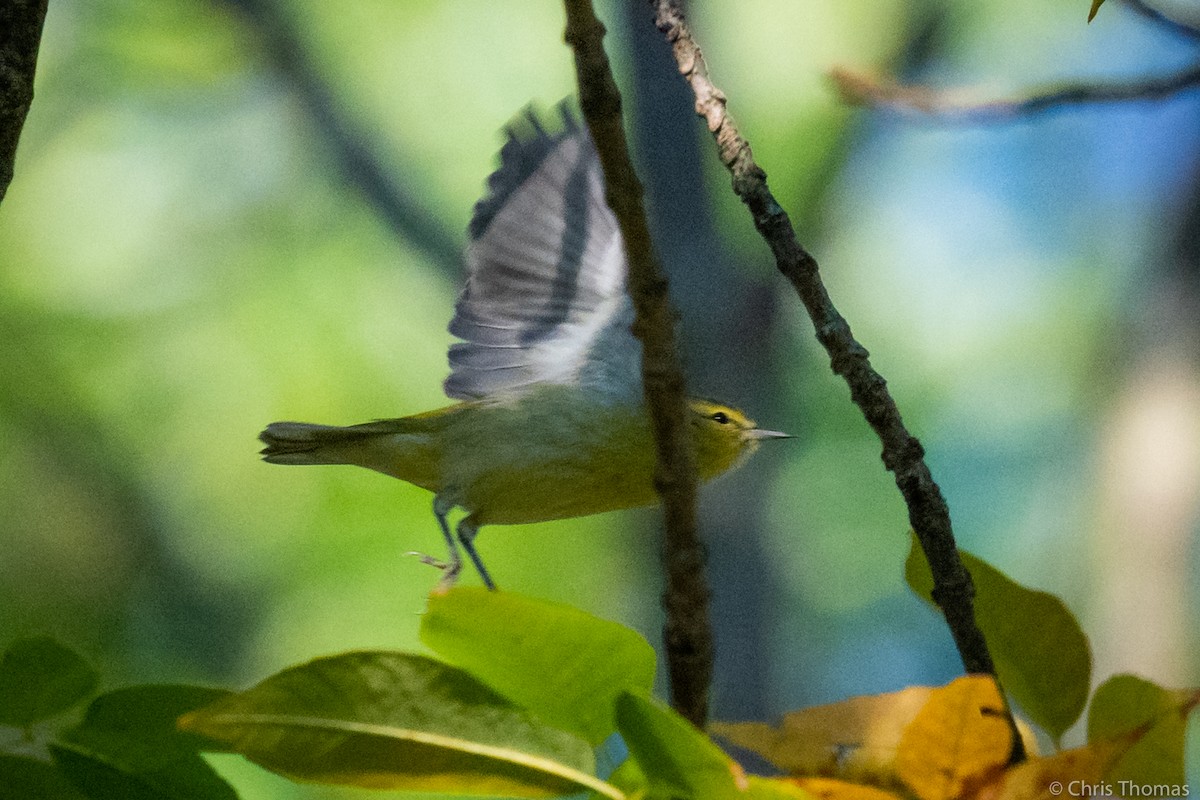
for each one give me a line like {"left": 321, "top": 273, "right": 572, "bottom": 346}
{"left": 652, "top": 0, "right": 1025, "bottom": 762}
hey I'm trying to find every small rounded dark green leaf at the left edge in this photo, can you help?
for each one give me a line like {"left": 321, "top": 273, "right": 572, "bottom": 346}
{"left": 0, "top": 637, "right": 96, "bottom": 728}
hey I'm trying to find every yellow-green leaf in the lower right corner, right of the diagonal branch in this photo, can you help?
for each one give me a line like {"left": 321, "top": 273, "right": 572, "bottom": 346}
{"left": 1087, "top": 675, "right": 1200, "bottom": 796}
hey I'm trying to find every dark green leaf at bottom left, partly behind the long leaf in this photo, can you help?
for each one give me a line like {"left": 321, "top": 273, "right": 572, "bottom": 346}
{"left": 52, "top": 685, "right": 238, "bottom": 800}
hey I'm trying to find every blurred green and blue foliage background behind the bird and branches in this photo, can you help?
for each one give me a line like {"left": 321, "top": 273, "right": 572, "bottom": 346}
{"left": 0, "top": 0, "right": 1200, "bottom": 798}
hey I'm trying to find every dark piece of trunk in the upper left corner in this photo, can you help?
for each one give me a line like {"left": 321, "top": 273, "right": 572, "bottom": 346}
{"left": 0, "top": 0, "right": 47, "bottom": 208}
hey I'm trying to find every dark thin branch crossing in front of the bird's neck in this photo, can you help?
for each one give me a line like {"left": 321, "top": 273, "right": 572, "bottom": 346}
{"left": 564, "top": 0, "right": 713, "bottom": 727}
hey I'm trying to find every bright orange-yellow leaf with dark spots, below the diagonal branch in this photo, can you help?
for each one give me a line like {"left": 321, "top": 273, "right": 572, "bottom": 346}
{"left": 895, "top": 675, "right": 1012, "bottom": 800}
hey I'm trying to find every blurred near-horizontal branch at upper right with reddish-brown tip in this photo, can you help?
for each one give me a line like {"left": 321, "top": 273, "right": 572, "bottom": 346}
{"left": 829, "top": 65, "right": 1200, "bottom": 122}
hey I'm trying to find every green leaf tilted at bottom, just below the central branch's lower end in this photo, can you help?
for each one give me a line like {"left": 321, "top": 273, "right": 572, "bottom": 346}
{"left": 617, "top": 692, "right": 744, "bottom": 800}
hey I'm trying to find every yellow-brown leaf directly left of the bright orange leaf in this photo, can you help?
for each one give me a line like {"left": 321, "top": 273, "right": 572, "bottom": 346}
{"left": 709, "top": 686, "right": 934, "bottom": 783}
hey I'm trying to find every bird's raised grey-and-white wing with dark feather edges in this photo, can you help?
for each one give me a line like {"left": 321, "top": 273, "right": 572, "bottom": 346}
{"left": 445, "top": 108, "right": 641, "bottom": 399}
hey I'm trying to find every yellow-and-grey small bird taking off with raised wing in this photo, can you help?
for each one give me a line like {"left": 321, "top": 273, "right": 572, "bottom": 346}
{"left": 259, "top": 110, "right": 787, "bottom": 590}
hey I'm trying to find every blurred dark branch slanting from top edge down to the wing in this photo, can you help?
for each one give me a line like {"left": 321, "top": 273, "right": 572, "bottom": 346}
{"left": 222, "top": 0, "right": 461, "bottom": 276}
